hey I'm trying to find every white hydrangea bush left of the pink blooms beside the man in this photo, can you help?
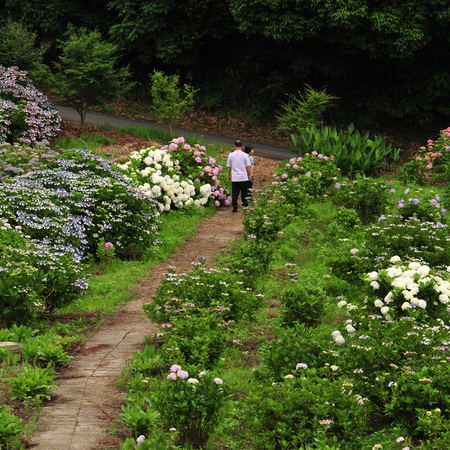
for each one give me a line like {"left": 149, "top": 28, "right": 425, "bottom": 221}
{"left": 117, "top": 147, "right": 212, "bottom": 212}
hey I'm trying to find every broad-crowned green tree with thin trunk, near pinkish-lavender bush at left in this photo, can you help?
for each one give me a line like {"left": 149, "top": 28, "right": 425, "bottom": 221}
{"left": 35, "top": 28, "right": 132, "bottom": 130}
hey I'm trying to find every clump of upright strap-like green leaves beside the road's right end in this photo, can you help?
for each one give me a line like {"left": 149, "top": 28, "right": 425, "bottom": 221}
{"left": 292, "top": 124, "right": 400, "bottom": 177}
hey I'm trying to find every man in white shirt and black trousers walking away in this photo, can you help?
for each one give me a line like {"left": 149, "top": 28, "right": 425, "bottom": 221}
{"left": 227, "top": 139, "right": 253, "bottom": 212}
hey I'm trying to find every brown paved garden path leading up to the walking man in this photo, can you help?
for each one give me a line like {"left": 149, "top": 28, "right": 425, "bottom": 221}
{"left": 31, "top": 208, "right": 242, "bottom": 450}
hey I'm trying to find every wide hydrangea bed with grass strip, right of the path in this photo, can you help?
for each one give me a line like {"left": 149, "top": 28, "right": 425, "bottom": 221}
{"left": 119, "top": 124, "right": 450, "bottom": 449}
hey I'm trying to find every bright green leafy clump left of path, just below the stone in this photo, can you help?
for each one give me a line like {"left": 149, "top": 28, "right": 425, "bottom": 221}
{"left": 8, "top": 365, "right": 57, "bottom": 400}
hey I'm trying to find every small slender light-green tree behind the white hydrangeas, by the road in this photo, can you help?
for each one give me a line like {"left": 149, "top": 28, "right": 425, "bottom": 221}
{"left": 151, "top": 70, "right": 197, "bottom": 136}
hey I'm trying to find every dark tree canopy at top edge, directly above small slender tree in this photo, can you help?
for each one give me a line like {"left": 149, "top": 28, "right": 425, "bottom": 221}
{"left": 109, "top": 0, "right": 236, "bottom": 67}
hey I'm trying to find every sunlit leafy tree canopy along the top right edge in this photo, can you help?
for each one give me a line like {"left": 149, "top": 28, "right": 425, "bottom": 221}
{"left": 230, "top": 0, "right": 436, "bottom": 58}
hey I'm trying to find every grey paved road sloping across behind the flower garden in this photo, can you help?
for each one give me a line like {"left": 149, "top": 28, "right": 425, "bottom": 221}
{"left": 57, "top": 106, "right": 293, "bottom": 161}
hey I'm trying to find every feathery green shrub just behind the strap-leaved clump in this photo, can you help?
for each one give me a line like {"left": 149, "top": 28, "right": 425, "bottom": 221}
{"left": 277, "top": 85, "right": 336, "bottom": 134}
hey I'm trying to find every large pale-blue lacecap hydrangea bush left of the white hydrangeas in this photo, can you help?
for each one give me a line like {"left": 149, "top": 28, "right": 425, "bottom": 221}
{"left": 0, "top": 151, "right": 162, "bottom": 256}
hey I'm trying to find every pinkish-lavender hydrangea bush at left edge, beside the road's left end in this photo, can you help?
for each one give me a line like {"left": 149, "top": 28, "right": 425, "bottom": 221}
{"left": 0, "top": 65, "right": 61, "bottom": 143}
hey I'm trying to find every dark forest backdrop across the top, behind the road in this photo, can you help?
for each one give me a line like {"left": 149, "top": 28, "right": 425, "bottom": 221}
{"left": 0, "top": 0, "right": 450, "bottom": 142}
